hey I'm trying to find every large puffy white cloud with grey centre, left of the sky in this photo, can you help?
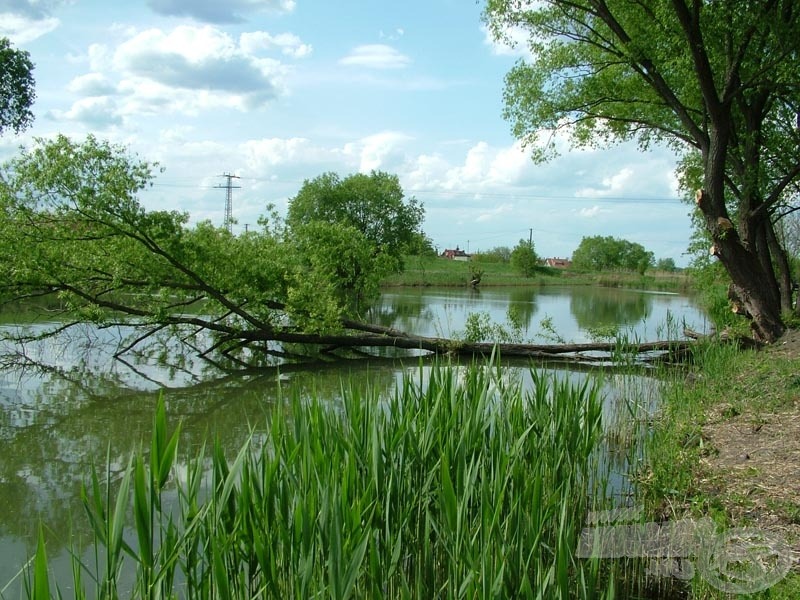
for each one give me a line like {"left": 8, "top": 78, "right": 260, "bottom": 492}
{"left": 43, "top": 25, "right": 296, "bottom": 124}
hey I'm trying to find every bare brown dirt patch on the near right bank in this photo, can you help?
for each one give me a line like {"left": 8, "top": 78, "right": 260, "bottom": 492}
{"left": 699, "top": 330, "right": 800, "bottom": 565}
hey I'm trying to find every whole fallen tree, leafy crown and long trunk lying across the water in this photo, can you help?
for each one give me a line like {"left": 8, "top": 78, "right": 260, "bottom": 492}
{"left": 0, "top": 137, "right": 686, "bottom": 370}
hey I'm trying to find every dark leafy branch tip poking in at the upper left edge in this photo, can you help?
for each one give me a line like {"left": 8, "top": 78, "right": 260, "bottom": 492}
{"left": 0, "top": 38, "right": 36, "bottom": 135}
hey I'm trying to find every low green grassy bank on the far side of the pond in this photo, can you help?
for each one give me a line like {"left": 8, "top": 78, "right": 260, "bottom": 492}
{"left": 382, "top": 256, "right": 690, "bottom": 292}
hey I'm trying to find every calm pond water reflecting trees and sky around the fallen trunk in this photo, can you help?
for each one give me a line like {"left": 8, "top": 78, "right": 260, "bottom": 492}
{"left": 0, "top": 287, "right": 706, "bottom": 596}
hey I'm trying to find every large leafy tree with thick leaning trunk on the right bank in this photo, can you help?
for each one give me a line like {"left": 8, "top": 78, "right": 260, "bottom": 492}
{"left": 485, "top": 0, "right": 800, "bottom": 341}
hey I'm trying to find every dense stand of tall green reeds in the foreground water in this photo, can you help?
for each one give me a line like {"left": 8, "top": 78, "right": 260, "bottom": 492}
{"left": 27, "top": 358, "right": 613, "bottom": 599}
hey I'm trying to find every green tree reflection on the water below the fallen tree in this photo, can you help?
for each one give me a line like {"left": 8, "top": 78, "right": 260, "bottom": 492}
{"left": 0, "top": 362, "right": 406, "bottom": 568}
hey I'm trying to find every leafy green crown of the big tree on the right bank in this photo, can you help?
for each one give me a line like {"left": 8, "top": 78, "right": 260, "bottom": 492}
{"left": 484, "top": 0, "right": 800, "bottom": 169}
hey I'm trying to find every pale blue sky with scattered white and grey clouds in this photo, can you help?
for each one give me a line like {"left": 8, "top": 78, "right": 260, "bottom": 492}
{"left": 0, "top": 0, "right": 691, "bottom": 266}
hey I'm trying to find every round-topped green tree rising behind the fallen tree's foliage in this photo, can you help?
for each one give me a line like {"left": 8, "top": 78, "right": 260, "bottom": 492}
{"left": 286, "top": 171, "right": 424, "bottom": 265}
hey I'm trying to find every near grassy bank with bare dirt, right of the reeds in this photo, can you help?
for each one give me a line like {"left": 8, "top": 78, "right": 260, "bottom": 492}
{"left": 641, "top": 331, "right": 800, "bottom": 600}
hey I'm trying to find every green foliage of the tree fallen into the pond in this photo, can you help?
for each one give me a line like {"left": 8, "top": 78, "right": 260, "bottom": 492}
{"left": 0, "top": 136, "right": 406, "bottom": 360}
